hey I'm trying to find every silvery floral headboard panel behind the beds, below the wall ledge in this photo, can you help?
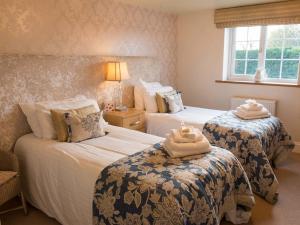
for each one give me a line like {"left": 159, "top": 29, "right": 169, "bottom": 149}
{"left": 0, "top": 55, "right": 172, "bottom": 151}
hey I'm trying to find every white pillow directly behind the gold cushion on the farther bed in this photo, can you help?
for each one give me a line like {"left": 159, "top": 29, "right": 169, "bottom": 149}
{"left": 144, "top": 86, "right": 173, "bottom": 113}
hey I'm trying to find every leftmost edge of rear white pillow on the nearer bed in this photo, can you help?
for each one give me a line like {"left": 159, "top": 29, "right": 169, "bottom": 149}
{"left": 19, "top": 103, "right": 43, "bottom": 138}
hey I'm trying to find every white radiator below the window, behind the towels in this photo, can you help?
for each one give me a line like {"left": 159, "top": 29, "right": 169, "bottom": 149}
{"left": 230, "top": 97, "right": 276, "bottom": 116}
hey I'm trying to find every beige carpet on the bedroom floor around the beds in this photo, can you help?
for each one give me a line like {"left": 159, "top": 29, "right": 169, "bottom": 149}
{"left": 0, "top": 153, "right": 300, "bottom": 225}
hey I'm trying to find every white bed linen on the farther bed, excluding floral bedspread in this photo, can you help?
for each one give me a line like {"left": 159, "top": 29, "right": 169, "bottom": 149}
{"left": 146, "top": 106, "right": 225, "bottom": 137}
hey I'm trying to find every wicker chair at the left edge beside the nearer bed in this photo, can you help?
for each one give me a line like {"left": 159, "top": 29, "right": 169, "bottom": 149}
{"left": 0, "top": 151, "right": 27, "bottom": 215}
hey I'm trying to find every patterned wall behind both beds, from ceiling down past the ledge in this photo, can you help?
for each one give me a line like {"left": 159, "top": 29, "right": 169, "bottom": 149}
{"left": 0, "top": 0, "right": 176, "bottom": 150}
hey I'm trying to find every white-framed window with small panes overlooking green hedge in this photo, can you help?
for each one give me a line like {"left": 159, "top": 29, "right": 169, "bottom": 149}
{"left": 227, "top": 24, "right": 300, "bottom": 83}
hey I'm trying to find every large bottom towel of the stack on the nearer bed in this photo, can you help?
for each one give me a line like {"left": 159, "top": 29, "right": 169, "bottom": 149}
{"left": 164, "top": 136, "right": 211, "bottom": 158}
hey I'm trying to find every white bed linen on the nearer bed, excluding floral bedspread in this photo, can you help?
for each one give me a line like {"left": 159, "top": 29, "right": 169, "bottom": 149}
{"left": 15, "top": 126, "right": 164, "bottom": 225}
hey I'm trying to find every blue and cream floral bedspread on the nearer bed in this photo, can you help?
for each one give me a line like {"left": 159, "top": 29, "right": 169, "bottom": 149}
{"left": 93, "top": 147, "right": 254, "bottom": 225}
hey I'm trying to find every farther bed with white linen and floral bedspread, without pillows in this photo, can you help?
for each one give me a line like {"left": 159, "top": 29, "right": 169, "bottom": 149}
{"left": 146, "top": 106, "right": 295, "bottom": 203}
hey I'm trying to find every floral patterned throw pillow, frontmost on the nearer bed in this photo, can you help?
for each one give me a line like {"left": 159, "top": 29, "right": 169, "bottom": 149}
{"left": 64, "top": 111, "right": 107, "bottom": 142}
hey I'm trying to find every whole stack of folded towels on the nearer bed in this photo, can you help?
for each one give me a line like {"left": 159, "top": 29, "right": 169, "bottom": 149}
{"left": 164, "top": 126, "right": 211, "bottom": 158}
